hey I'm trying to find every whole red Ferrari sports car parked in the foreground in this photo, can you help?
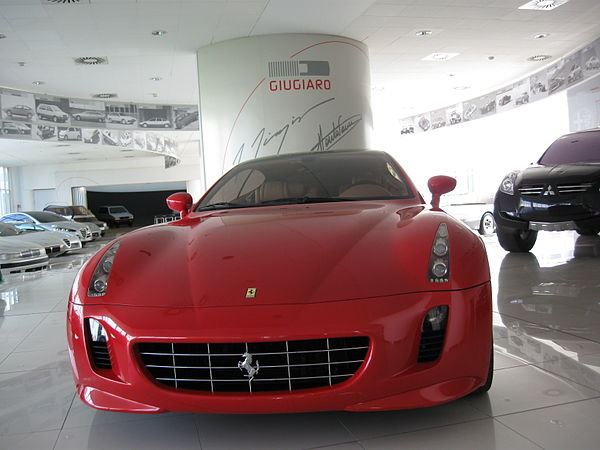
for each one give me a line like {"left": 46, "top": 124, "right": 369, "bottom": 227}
{"left": 68, "top": 151, "right": 493, "bottom": 413}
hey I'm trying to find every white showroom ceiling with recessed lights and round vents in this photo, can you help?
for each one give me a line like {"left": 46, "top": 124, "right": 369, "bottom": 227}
{"left": 0, "top": 0, "right": 600, "bottom": 164}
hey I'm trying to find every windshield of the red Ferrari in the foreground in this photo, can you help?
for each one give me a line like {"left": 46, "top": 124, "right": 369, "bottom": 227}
{"left": 196, "top": 152, "right": 413, "bottom": 211}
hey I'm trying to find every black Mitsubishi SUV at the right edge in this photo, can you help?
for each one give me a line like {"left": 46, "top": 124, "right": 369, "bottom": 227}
{"left": 494, "top": 130, "right": 600, "bottom": 252}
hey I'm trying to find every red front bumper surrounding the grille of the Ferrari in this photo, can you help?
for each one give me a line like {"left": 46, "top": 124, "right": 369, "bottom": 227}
{"left": 68, "top": 282, "right": 492, "bottom": 413}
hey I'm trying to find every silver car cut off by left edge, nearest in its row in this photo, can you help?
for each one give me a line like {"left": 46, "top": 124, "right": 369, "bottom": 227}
{"left": 0, "top": 238, "right": 48, "bottom": 276}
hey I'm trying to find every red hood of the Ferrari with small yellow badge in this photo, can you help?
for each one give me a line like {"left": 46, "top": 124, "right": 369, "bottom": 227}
{"left": 86, "top": 202, "right": 489, "bottom": 307}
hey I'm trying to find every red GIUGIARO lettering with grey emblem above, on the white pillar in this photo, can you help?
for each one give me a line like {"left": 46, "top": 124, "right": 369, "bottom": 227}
{"left": 269, "top": 61, "right": 331, "bottom": 92}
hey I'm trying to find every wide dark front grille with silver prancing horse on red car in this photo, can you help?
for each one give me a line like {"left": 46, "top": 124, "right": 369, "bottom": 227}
{"left": 137, "top": 336, "right": 369, "bottom": 392}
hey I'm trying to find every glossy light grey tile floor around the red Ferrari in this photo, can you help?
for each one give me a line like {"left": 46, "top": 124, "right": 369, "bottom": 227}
{"left": 0, "top": 232, "right": 600, "bottom": 450}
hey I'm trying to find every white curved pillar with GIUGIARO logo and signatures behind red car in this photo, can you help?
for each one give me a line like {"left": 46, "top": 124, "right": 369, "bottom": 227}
{"left": 198, "top": 34, "right": 372, "bottom": 186}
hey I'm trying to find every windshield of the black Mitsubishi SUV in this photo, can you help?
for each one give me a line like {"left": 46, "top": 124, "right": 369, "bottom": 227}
{"left": 538, "top": 132, "right": 600, "bottom": 166}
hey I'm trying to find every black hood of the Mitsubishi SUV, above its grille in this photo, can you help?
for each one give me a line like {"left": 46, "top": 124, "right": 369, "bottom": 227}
{"left": 516, "top": 163, "right": 600, "bottom": 186}
